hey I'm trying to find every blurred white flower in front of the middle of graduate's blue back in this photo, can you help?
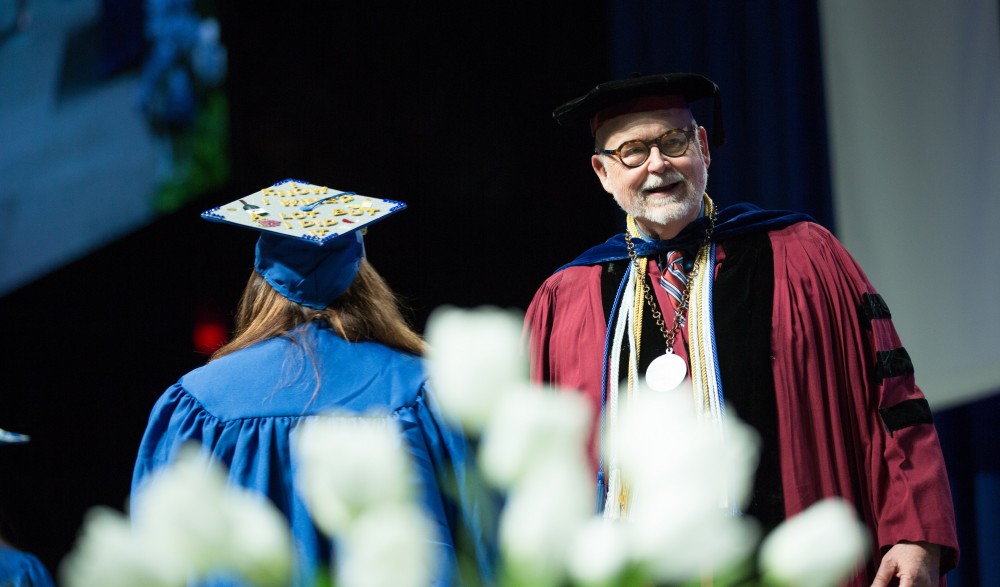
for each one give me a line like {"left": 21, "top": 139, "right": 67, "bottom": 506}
{"left": 293, "top": 415, "right": 410, "bottom": 536}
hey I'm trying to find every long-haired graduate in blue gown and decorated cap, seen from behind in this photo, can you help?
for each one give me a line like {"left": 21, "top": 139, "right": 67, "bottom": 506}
{"left": 132, "top": 180, "right": 489, "bottom": 585}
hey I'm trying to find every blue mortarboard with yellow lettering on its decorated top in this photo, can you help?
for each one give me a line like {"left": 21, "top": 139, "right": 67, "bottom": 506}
{"left": 202, "top": 179, "right": 406, "bottom": 309}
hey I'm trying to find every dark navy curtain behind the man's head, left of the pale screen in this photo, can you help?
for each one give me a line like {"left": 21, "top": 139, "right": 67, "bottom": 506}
{"left": 610, "top": 0, "right": 834, "bottom": 230}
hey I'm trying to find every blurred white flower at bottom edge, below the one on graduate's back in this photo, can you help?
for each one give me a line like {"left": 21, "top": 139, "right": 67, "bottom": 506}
{"left": 337, "top": 503, "right": 442, "bottom": 587}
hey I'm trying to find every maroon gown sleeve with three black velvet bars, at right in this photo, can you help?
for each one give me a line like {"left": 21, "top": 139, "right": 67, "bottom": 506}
{"left": 772, "top": 223, "right": 958, "bottom": 575}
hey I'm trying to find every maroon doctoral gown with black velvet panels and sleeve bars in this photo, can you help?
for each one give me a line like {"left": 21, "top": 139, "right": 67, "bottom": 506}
{"left": 525, "top": 217, "right": 958, "bottom": 586}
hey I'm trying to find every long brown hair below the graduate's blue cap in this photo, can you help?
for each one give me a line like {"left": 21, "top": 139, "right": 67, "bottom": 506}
{"left": 210, "top": 259, "right": 425, "bottom": 360}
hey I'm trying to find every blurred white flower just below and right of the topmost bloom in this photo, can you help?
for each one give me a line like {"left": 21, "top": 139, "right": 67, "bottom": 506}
{"left": 479, "top": 383, "right": 593, "bottom": 489}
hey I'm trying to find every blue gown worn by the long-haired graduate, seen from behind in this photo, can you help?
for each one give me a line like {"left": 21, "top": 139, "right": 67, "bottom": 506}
{"left": 132, "top": 325, "right": 490, "bottom": 585}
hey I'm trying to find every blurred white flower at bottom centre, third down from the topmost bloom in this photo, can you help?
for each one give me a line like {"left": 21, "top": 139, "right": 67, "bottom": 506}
{"left": 500, "top": 459, "right": 594, "bottom": 585}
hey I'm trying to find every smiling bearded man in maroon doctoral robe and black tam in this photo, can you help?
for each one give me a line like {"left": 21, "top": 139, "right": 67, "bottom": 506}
{"left": 525, "top": 74, "right": 958, "bottom": 587}
